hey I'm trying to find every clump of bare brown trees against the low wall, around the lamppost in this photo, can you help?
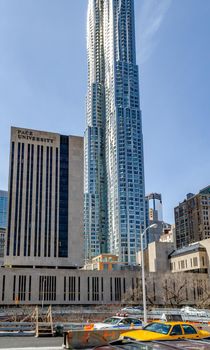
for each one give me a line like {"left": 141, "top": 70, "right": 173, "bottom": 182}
{"left": 121, "top": 272, "right": 210, "bottom": 308}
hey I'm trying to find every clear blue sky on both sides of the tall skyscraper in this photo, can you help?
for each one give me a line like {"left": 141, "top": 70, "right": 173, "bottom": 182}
{"left": 0, "top": 0, "right": 210, "bottom": 222}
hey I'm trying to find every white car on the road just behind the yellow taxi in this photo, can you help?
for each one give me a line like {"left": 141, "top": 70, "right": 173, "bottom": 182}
{"left": 94, "top": 316, "right": 142, "bottom": 329}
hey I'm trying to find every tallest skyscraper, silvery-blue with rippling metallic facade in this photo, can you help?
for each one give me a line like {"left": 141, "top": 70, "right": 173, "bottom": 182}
{"left": 84, "top": 0, "right": 145, "bottom": 263}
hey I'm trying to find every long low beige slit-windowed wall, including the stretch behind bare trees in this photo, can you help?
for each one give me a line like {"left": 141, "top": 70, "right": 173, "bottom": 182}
{"left": 0, "top": 268, "right": 210, "bottom": 306}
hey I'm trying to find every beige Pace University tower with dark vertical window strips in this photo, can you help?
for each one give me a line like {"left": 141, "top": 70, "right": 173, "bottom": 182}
{"left": 5, "top": 128, "right": 84, "bottom": 267}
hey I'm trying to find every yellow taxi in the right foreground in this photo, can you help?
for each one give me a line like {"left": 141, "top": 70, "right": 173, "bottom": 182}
{"left": 120, "top": 322, "right": 210, "bottom": 341}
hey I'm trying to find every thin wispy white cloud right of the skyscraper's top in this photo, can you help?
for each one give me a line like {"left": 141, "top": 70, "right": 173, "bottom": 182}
{"left": 137, "top": 0, "right": 172, "bottom": 63}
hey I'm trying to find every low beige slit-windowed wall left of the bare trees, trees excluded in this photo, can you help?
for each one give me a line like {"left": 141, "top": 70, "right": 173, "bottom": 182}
{"left": 0, "top": 268, "right": 139, "bottom": 305}
